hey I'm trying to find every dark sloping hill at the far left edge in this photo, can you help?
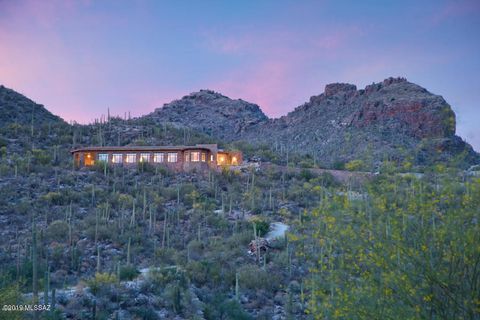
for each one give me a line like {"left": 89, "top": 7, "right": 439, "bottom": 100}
{"left": 0, "top": 85, "right": 63, "bottom": 127}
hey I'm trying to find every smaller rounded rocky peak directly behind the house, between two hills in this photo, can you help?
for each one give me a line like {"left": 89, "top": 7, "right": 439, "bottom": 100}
{"left": 146, "top": 90, "right": 268, "bottom": 140}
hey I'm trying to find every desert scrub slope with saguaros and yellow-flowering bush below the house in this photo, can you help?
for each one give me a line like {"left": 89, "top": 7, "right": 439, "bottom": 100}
{"left": 0, "top": 122, "right": 480, "bottom": 319}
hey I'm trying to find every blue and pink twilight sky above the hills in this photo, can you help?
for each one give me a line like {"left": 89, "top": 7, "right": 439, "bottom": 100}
{"left": 0, "top": 0, "right": 480, "bottom": 151}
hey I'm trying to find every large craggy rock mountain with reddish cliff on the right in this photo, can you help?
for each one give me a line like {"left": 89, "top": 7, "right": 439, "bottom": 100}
{"left": 245, "top": 78, "right": 479, "bottom": 165}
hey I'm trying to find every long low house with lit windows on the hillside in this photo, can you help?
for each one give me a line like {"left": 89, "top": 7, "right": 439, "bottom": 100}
{"left": 71, "top": 144, "right": 243, "bottom": 171}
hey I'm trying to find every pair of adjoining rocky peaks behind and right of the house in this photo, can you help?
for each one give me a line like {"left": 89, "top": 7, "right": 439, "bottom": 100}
{"left": 145, "top": 78, "right": 480, "bottom": 167}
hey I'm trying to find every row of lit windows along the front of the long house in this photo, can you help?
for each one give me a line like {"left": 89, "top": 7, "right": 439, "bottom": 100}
{"left": 98, "top": 151, "right": 209, "bottom": 163}
